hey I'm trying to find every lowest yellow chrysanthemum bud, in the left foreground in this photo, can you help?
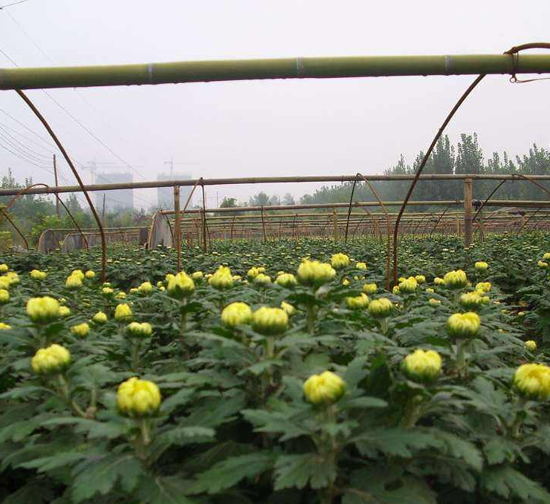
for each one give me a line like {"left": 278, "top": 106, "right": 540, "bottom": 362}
{"left": 117, "top": 376, "right": 162, "bottom": 418}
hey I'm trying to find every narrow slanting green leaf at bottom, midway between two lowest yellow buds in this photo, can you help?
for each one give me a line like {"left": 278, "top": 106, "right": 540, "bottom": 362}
{"left": 189, "top": 452, "right": 275, "bottom": 494}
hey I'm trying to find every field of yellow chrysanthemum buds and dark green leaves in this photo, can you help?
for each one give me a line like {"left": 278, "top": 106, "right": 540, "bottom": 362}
{"left": 0, "top": 233, "right": 550, "bottom": 504}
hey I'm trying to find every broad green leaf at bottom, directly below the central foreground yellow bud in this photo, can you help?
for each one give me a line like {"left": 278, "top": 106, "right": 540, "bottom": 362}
{"left": 274, "top": 453, "right": 337, "bottom": 490}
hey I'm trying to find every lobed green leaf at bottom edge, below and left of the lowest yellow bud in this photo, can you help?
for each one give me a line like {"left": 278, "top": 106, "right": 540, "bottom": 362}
{"left": 72, "top": 454, "right": 145, "bottom": 502}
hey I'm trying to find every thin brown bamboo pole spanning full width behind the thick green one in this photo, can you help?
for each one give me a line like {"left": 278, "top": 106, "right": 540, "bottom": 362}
{"left": 0, "top": 173, "right": 550, "bottom": 197}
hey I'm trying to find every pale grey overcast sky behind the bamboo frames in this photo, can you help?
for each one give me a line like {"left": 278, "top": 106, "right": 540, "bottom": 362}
{"left": 0, "top": 0, "right": 550, "bottom": 206}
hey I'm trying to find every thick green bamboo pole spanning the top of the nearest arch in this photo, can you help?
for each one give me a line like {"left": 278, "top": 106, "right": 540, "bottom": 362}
{"left": 0, "top": 54, "right": 550, "bottom": 90}
